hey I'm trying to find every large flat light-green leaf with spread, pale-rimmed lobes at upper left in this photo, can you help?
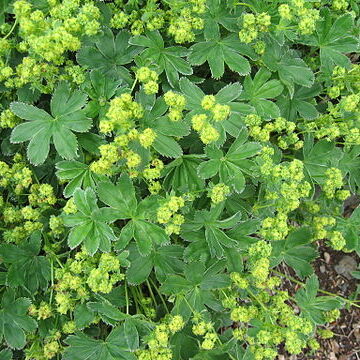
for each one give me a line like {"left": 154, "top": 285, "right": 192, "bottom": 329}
{"left": 10, "top": 82, "right": 92, "bottom": 165}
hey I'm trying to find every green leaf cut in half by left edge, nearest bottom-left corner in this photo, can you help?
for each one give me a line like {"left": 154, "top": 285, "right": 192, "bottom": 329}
{"left": 0, "top": 289, "right": 37, "bottom": 349}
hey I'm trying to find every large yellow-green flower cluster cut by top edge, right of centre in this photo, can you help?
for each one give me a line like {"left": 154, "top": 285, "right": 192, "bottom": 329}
{"left": 278, "top": 0, "right": 320, "bottom": 35}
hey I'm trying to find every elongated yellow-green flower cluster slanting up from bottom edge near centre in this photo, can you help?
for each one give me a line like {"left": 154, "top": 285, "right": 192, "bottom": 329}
{"left": 136, "top": 315, "right": 185, "bottom": 360}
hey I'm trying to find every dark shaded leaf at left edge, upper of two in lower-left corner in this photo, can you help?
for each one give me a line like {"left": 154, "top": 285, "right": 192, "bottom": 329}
{"left": 0, "top": 231, "right": 50, "bottom": 293}
